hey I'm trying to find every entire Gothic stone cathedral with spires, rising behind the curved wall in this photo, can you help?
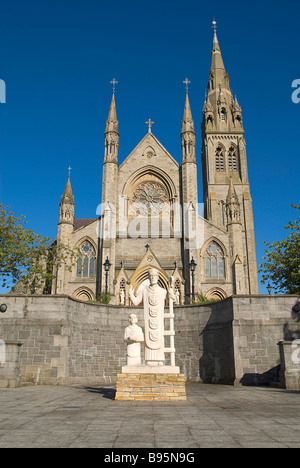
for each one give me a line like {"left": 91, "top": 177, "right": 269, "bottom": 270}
{"left": 52, "top": 28, "right": 258, "bottom": 306}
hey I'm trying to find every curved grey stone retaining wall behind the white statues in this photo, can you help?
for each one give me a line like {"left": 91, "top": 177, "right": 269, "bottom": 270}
{"left": 0, "top": 295, "right": 299, "bottom": 385}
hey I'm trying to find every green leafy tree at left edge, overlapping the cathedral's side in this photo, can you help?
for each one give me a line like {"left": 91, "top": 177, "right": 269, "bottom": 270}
{"left": 0, "top": 203, "right": 77, "bottom": 294}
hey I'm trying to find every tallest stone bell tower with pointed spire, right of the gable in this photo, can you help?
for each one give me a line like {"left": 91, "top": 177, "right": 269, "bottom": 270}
{"left": 202, "top": 21, "right": 258, "bottom": 294}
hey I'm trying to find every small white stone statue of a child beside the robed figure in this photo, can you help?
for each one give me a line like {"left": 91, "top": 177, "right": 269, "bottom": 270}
{"left": 124, "top": 314, "right": 144, "bottom": 366}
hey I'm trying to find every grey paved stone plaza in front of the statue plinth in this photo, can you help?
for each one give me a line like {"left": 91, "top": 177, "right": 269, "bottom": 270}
{"left": 0, "top": 384, "right": 300, "bottom": 448}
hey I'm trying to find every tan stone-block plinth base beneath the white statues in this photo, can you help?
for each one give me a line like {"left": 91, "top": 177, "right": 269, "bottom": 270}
{"left": 115, "top": 373, "right": 186, "bottom": 401}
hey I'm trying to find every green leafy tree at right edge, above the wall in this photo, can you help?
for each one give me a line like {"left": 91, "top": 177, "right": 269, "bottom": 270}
{"left": 260, "top": 205, "right": 300, "bottom": 294}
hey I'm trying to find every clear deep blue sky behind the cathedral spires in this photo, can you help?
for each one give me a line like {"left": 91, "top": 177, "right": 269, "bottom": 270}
{"left": 0, "top": 0, "right": 300, "bottom": 292}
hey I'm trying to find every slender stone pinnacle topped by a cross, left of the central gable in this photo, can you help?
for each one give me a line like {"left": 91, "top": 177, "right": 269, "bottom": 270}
{"left": 104, "top": 85, "right": 119, "bottom": 163}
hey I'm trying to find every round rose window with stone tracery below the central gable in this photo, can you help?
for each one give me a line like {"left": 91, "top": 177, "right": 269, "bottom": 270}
{"left": 132, "top": 182, "right": 168, "bottom": 215}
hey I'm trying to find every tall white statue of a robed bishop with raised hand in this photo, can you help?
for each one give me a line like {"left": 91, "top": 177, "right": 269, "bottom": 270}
{"left": 129, "top": 268, "right": 176, "bottom": 366}
